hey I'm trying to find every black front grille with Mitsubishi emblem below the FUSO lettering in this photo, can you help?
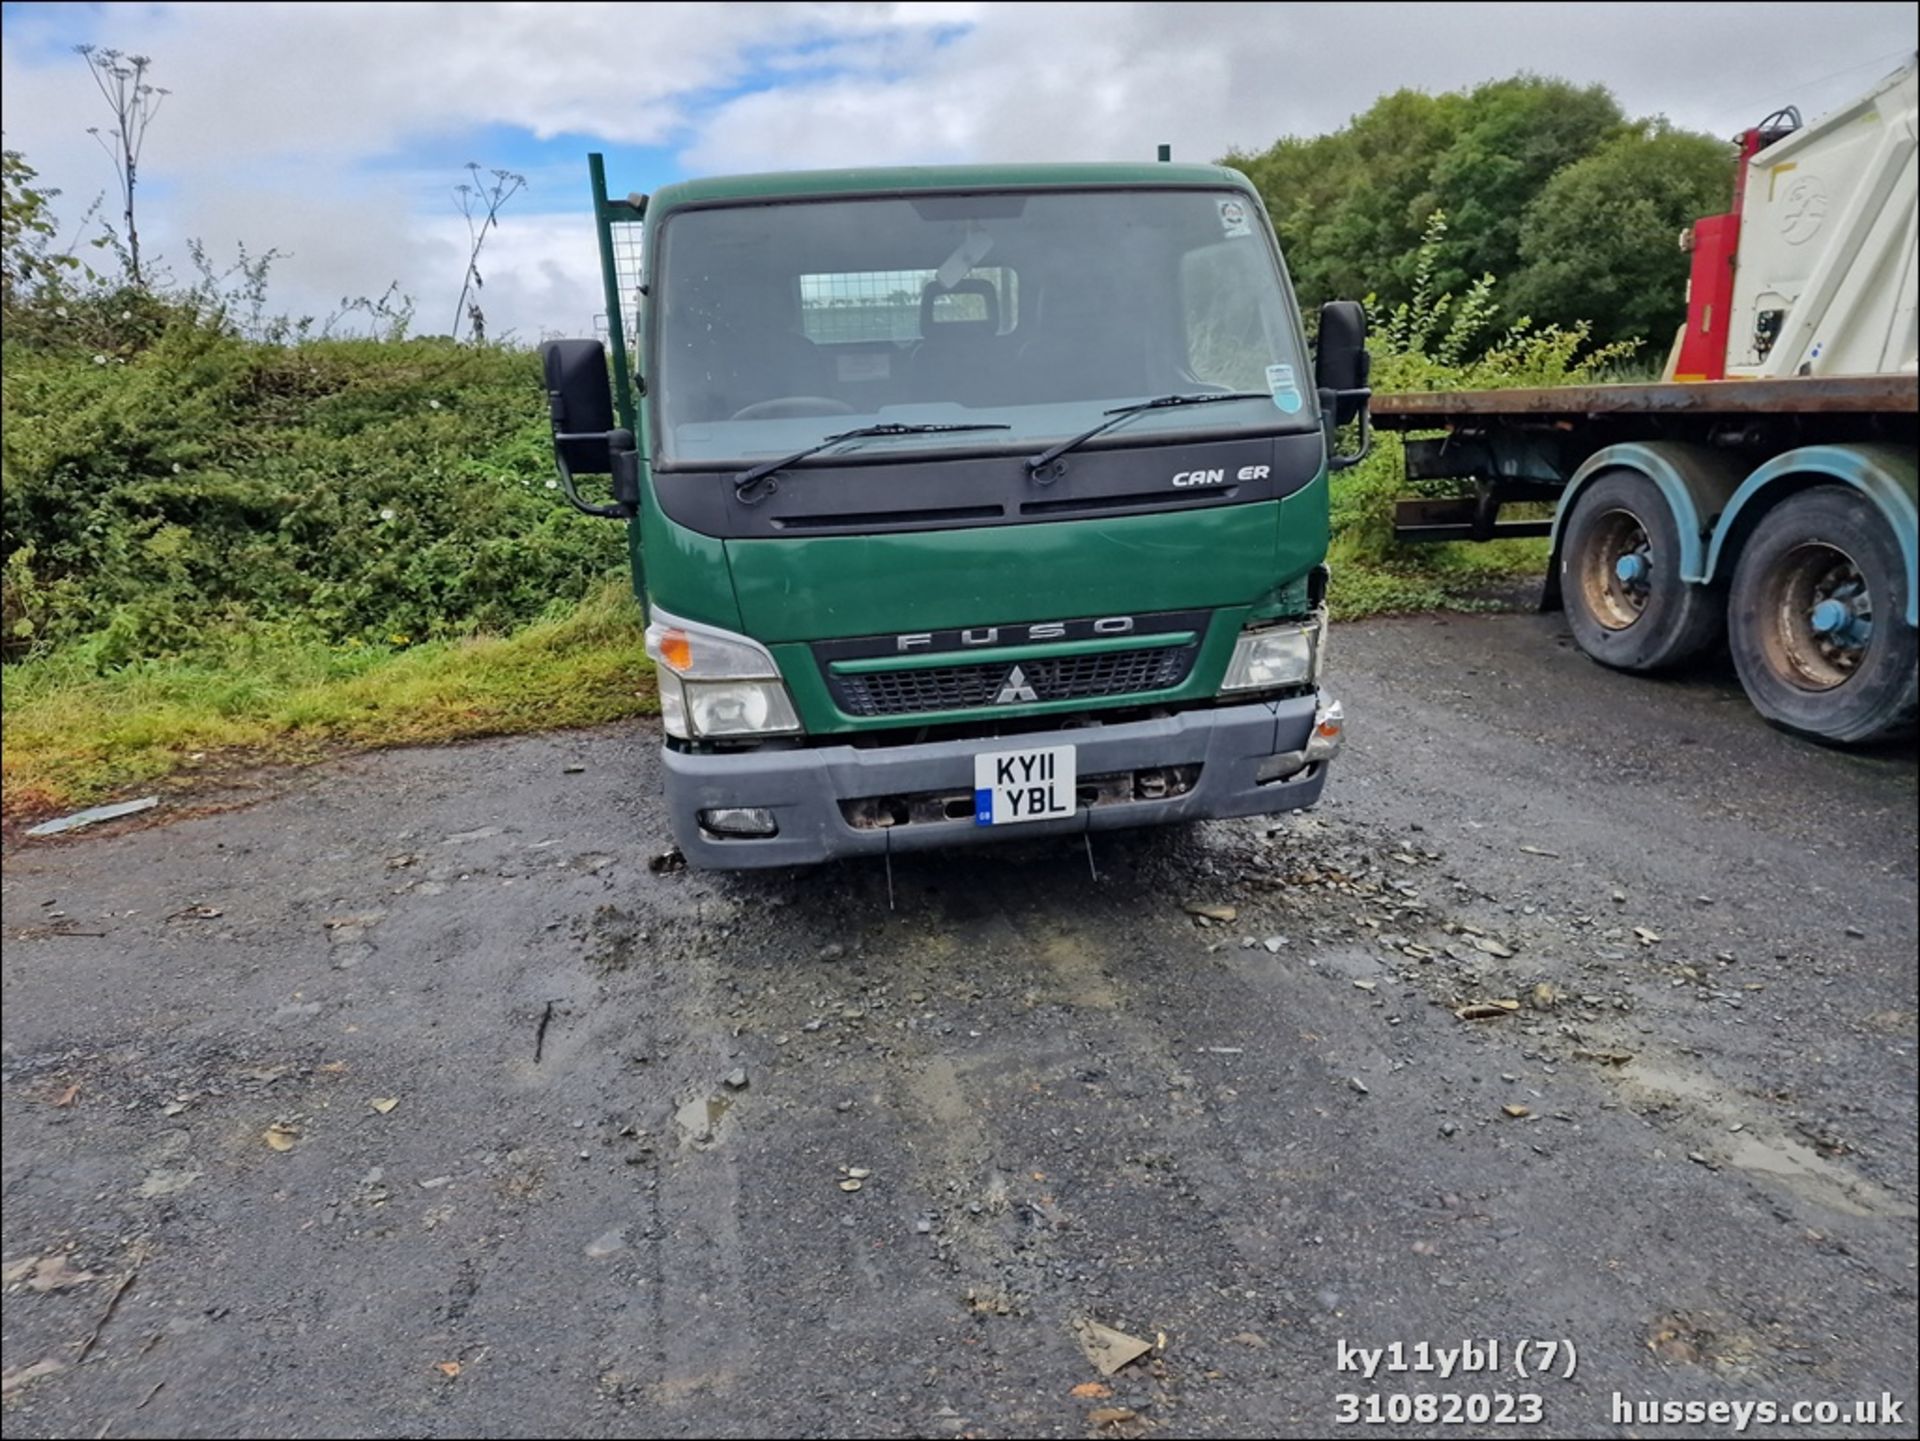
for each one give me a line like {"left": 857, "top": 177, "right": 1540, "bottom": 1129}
{"left": 828, "top": 645, "right": 1196, "bottom": 716}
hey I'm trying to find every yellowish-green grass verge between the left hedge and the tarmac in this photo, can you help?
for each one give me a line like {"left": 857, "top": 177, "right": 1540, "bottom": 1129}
{"left": 0, "top": 581, "right": 659, "bottom": 819}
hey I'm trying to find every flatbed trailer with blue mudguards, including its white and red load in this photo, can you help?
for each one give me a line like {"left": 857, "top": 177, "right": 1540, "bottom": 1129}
{"left": 1373, "top": 63, "right": 1920, "bottom": 743}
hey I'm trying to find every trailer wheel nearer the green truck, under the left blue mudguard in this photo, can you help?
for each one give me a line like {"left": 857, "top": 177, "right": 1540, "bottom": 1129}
{"left": 1559, "top": 470, "right": 1726, "bottom": 672}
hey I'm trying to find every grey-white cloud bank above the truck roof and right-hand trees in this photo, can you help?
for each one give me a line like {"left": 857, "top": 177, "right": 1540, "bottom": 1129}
{"left": 685, "top": 2, "right": 1912, "bottom": 171}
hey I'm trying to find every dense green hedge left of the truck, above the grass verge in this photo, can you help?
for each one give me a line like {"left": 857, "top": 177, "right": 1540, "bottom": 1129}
{"left": 0, "top": 314, "right": 622, "bottom": 666}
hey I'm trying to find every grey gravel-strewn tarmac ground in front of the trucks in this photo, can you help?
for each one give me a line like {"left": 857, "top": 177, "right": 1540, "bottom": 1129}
{"left": 0, "top": 616, "right": 1920, "bottom": 1437}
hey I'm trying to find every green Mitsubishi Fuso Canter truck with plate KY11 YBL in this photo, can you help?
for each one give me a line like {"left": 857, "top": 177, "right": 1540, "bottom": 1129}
{"left": 541, "top": 155, "right": 1369, "bottom": 867}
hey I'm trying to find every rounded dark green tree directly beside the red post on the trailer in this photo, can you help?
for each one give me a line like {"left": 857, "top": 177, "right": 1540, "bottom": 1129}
{"left": 1513, "top": 121, "right": 1734, "bottom": 351}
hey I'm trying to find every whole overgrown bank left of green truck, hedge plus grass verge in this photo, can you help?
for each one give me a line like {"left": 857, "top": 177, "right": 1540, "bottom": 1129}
{"left": 0, "top": 232, "right": 653, "bottom": 819}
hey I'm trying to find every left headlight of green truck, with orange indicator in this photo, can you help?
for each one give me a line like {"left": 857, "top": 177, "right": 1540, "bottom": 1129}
{"left": 647, "top": 608, "right": 801, "bottom": 741}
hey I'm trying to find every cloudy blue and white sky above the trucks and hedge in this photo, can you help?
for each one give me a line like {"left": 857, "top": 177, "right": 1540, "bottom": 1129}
{"left": 0, "top": 0, "right": 1916, "bottom": 340}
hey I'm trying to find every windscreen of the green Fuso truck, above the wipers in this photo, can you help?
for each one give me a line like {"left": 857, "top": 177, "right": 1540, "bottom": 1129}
{"left": 649, "top": 190, "right": 1311, "bottom": 466}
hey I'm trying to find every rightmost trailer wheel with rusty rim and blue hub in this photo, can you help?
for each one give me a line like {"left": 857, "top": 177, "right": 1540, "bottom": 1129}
{"left": 1728, "top": 485, "right": 1920, "bottom": 744}
